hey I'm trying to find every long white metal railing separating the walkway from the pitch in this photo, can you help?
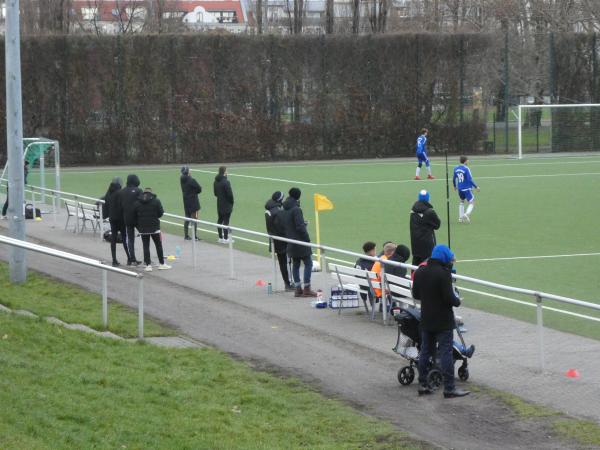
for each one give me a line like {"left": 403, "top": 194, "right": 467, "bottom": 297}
{"left": 4, "top": 181, "right": 600, "bottom": 371}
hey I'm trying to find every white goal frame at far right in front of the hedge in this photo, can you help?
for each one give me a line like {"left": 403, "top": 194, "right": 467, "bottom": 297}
{"left": 516, "top": 103, "right": 600, "bottom": 159}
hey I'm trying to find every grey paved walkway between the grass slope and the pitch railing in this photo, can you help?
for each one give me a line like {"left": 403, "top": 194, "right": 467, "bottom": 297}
{"left": 0, "top": 208, "right": 600, "bottom": 449}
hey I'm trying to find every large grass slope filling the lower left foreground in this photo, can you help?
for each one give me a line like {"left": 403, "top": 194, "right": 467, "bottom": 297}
{"left": 0, "top": 314, "right": 423, "bottom": 449}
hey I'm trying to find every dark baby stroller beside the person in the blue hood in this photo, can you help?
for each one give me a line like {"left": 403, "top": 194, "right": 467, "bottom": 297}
{"left": 392, "top": 307, "right": 475, "bottom": 389}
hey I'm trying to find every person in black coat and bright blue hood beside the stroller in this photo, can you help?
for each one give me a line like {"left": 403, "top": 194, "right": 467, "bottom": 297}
{"left": 412, "top": 245, "right": 469, "bottom": 398}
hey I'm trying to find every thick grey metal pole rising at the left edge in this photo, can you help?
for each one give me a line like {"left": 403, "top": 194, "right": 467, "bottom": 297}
{"left": 4, "top": 0, "right": 27, "bottom": 283}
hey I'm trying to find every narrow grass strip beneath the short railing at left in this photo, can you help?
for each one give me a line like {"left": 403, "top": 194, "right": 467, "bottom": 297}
{"left": 0, "top": 262, "right": 175, "bottom": 337}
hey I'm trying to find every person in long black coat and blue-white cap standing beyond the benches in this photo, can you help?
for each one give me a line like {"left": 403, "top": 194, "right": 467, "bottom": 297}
{"left": 410, "top": 190, "right": 441, "bottom": 266}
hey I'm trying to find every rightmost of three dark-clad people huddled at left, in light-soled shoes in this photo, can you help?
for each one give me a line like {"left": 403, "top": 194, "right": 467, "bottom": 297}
{"left": 134, "top": 188, "right": 171, "bottom": 272}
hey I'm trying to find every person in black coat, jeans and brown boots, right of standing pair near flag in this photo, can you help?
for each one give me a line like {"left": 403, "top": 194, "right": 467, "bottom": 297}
{"left": 282, "top": 187, "right": 317, "bottom": 297}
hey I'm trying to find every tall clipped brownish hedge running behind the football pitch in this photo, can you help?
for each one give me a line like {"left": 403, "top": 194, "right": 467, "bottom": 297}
{"left": 0, "top": 34, "right": 597, "bottom": 165}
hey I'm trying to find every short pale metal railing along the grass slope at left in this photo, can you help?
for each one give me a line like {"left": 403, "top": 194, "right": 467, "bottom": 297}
{"left": 0, "top": 235, "right": 144, "bottom": 339}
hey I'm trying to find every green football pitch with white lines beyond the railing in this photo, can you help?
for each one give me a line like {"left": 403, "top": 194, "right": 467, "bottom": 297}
{"left": 29, "top": 155, "right": 600, "bottom": 337}
